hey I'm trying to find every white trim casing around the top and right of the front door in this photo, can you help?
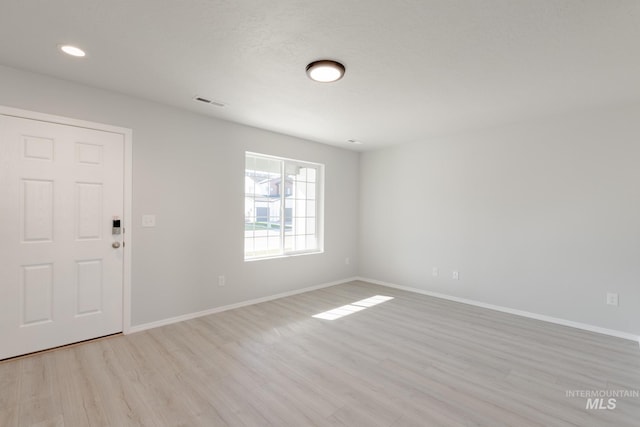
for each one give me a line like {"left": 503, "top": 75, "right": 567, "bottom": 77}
{"left": 0, "top": 105, "right": 133, "bottom": 334}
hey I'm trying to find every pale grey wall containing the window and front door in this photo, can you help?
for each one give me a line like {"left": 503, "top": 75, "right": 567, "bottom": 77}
{"left": 0, "top": 67, "right": 359, "bottom": 326}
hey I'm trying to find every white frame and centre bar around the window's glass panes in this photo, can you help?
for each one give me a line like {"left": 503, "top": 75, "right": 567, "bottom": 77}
{"left": 243, "top": 151, "right": 324, "bottom": 261}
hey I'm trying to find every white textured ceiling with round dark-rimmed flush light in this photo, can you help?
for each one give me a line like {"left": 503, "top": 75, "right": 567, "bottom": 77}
{"left": 0, "top": 0, "right": 640, "bottom": 150}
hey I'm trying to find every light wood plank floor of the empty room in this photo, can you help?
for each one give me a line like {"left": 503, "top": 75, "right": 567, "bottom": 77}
{"left": 0, "top": 282, "right": 640, "bottom": 427}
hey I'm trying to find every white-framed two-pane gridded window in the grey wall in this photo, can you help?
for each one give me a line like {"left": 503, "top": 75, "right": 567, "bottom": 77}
{"left": 244, "top": 152, "right": 324, "bottom": 260}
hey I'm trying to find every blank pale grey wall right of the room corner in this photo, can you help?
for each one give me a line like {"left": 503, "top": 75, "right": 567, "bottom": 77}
{"left": 359, "top": 106, "right": 640, "bottom": 335}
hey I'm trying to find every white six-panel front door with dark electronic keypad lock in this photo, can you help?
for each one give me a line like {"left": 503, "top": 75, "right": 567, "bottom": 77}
{"left": 0, "top": 115, "right": 125, "bottom": 359}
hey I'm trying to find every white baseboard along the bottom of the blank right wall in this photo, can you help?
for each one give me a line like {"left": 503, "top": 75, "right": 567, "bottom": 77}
{"left": 357, "top": 277, "right": 640, "bottom": 345}
